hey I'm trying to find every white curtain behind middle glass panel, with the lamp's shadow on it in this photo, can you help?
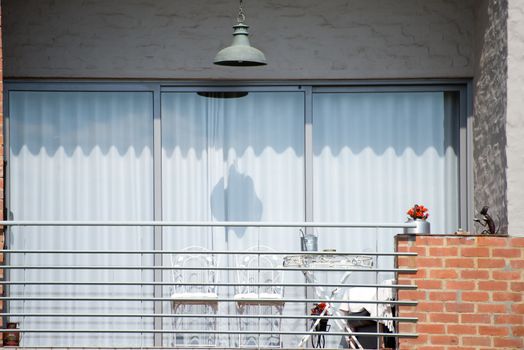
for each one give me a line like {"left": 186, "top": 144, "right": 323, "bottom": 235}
{"left": 162, "top": 92, "right": 304, "bottom": 346}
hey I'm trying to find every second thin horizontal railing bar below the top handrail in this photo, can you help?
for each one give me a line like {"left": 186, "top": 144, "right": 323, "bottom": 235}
{"left": 1, "top": 265, "right": 417, "bottom": 273}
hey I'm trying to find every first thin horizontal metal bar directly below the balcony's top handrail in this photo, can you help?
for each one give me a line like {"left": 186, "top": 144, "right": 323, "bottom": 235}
{"left": 0, "top": 249, "right": 417, "bottom": 256}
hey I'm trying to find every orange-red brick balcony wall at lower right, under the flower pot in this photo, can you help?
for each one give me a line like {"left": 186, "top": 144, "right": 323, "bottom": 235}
{"left": 397, "top": 235, "right": 524, "bottom": 350}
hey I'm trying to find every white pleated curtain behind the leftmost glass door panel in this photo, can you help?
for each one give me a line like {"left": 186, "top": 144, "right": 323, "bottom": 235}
{"left": 9, "top": 92, "right": 153, "bottom": 346}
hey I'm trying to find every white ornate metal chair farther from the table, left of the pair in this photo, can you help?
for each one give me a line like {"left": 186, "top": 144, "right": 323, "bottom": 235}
{"left": 171, "top": 247, "right": 218, "bottom": 347}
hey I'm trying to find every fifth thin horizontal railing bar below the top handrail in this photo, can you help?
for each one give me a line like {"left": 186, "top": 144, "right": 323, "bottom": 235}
{"left": 0, "top": 312, "right": 418, "bottom": 322}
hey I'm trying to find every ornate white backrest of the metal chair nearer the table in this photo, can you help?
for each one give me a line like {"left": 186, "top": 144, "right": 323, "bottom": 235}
{"left": 236, "top": 246, "right": 284, "bottom": 296}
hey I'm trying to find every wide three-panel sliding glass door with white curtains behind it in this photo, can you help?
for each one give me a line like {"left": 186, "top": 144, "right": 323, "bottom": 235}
{"left": 6, "top": 83, "right": 467, "bottom": 346}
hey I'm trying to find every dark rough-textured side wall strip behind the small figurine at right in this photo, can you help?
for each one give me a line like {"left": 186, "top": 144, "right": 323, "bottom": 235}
{"left": 473, "top": 0, "right": 508, "bottom": 233}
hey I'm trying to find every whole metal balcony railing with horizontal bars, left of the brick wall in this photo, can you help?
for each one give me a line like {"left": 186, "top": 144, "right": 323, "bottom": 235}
{"left": 0, "top": 221, "right": 417, "bottom": 349}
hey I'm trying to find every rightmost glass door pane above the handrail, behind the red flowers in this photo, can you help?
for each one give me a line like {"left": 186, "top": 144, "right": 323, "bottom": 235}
{"left": 313, "top": 92, "right": 459, "bottom": 233}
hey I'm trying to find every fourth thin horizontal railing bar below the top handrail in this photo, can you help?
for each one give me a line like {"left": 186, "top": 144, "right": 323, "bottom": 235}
{"left": 0, "top": 297, "right": 418, "bottom": 306}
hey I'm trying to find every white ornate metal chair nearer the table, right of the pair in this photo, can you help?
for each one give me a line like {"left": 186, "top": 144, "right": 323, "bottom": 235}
{"left": 234, "top": 246, "right": 284, "bottom": 348}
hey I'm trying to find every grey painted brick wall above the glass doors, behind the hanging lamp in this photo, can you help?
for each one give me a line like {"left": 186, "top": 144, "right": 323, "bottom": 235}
{"left": 2, "top": 0, "right": 475, "bottom": 79}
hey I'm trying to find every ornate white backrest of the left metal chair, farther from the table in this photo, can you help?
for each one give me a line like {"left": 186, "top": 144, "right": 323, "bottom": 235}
{"left": 171, "top": 246, "right": 218, "bottom": 293}
